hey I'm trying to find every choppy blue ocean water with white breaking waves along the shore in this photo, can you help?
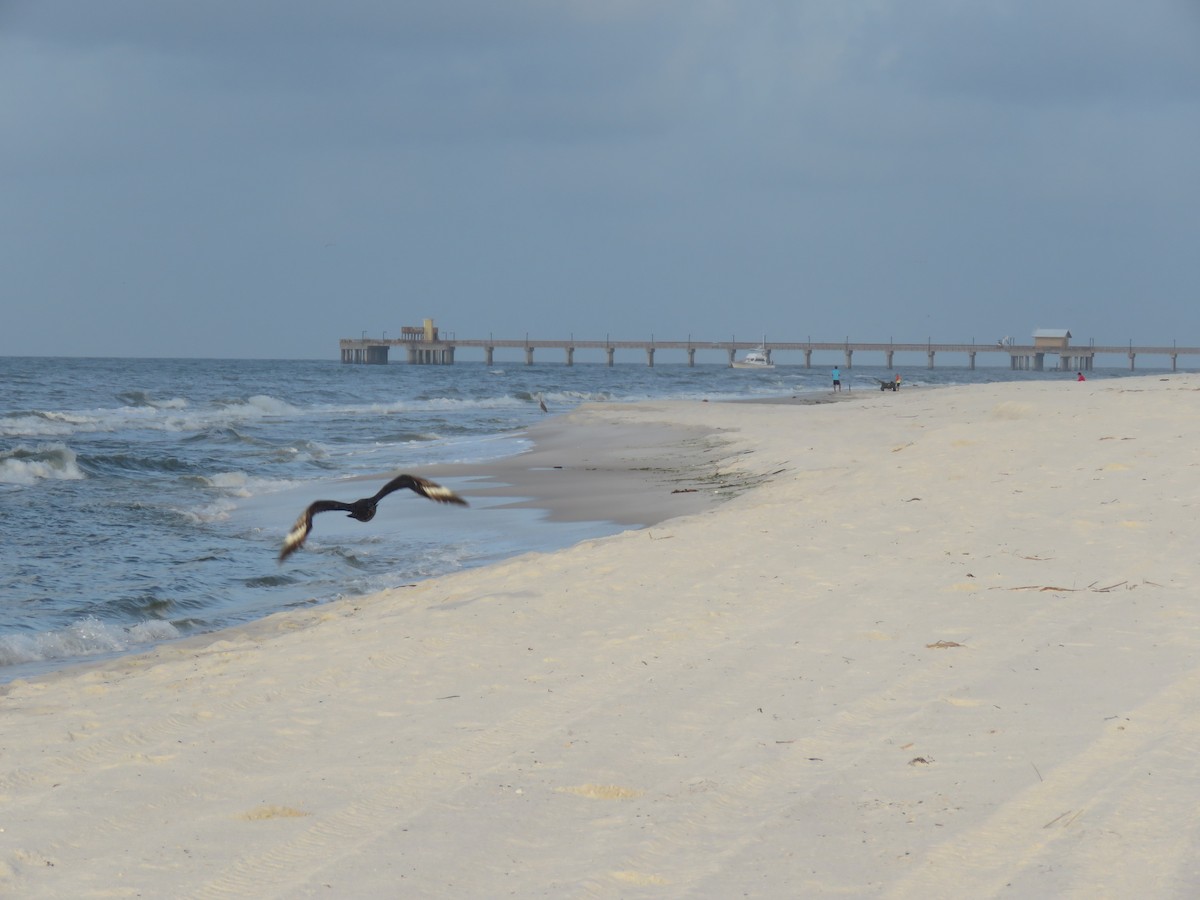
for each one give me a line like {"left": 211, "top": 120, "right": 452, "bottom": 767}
{"left": 0, "top": 354, "right": 1171, "bottom": 682}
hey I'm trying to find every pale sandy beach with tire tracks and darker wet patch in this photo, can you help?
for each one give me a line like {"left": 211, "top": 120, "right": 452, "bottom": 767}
{"left": 0, "top": 374, "right": 1200, "bottom": 898}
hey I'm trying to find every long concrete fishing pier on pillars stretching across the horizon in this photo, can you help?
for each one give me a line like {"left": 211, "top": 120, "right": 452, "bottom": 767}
{"left": 340, "top": 319, "right": 1200, "bottom": 372}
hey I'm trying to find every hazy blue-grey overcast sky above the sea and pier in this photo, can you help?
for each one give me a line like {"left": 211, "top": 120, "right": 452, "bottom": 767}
{"left": 0, "top": 0, "right": 1200, "bottom": 361}
